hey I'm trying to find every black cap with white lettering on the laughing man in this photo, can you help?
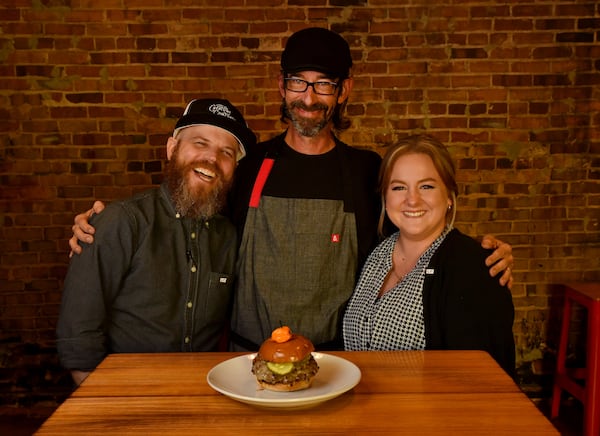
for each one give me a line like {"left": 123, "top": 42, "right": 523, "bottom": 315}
{"left": 173, "top": 98, "right": 256, "bottom": 160}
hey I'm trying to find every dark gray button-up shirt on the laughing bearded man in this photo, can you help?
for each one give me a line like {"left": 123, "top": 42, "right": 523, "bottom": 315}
{"left": 57, "top": 184, "right": 237, "bottom": 370}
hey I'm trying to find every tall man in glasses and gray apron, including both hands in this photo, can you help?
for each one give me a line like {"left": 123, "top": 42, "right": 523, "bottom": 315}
{"left": 71, "top": 28, "right": 512, "bottom": 351}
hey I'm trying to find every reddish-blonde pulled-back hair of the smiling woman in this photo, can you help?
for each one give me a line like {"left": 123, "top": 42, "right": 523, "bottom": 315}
{"left": 377, "top": 134, "right": 458, "bottom": 236}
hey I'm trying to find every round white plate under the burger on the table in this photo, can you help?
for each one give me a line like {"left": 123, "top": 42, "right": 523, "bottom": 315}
{"left": 206, "top": 352, "right": 361, "bottom": 408}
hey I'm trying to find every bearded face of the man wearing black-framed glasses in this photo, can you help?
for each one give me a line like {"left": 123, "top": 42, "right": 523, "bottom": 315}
{"left": 279, "top": 71, "right": 352, "bottom": 138}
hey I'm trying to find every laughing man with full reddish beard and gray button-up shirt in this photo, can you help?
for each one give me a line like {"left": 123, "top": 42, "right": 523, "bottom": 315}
{"left": 57, "top": 99, "right": 256, "bottom": 385}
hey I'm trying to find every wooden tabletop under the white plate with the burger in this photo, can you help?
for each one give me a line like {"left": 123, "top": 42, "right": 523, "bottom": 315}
{"left": 37, "top": 351, "right": 558, "bottom": 436}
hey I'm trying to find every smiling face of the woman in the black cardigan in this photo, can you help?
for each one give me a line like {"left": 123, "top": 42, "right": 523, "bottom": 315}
{"left": 384, "top": 153, "right": 452, "bottom": 242}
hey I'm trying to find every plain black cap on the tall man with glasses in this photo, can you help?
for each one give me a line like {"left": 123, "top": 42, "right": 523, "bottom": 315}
{"left": 281, "top": 27, "right": 352, "bottom": 79}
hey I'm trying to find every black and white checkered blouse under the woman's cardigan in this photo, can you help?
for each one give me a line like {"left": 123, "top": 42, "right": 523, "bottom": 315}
{"left": 344, "top": 228, "right": 451, "bottom": 350}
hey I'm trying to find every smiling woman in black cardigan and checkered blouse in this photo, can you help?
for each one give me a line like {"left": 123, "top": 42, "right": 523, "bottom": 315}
{"left": 343, "top": 135, "right": 515, "bottom": 375}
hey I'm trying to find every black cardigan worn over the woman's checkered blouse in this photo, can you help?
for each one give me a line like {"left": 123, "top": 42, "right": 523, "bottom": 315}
{"left": 423, "top": 229, "right": 515, "bottom": 378}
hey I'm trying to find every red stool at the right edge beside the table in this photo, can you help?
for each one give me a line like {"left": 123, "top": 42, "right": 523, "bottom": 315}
{"left": 551, "top": 282, "right": 600, "bottom": 436}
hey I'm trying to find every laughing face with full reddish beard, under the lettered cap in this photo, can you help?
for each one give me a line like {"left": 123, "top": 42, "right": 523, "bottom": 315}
{"left": 166, "top": 125, "right": 239, "bottom": 218}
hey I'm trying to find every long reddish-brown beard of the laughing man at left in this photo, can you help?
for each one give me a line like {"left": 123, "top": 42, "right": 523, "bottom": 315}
{"left": 166, "top": 146, "right": 231, "bottom": 220}
